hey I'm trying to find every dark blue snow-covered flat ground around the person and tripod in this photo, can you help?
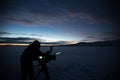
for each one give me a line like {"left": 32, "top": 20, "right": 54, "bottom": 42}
{"left": 0, "top": 46, "right": 120, "bottom": 80}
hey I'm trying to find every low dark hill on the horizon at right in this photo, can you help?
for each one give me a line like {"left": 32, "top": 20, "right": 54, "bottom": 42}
{"left": 68, "top": 39, "right": 120, "bottom": 46}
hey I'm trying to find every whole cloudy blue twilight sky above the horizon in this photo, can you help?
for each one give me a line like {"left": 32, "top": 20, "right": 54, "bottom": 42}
{"left": 0, "top": 0, "right": 120, "bottom": 44}
